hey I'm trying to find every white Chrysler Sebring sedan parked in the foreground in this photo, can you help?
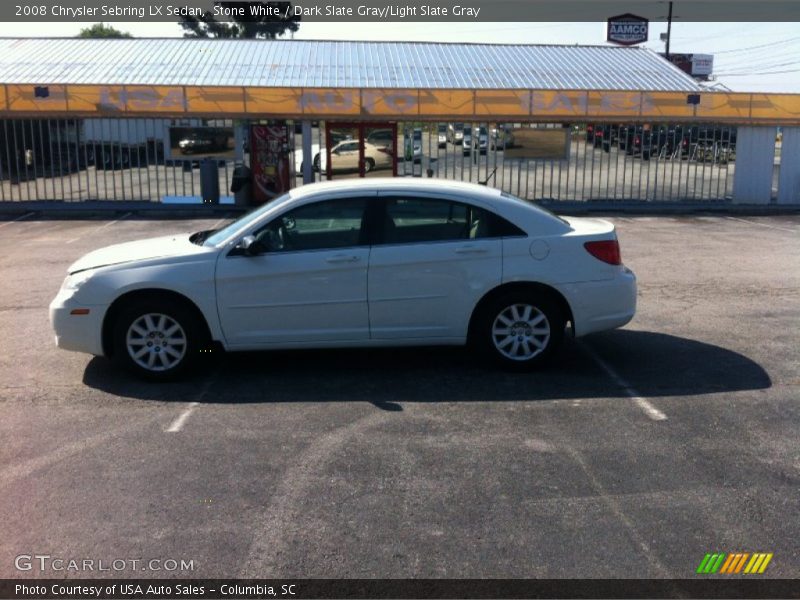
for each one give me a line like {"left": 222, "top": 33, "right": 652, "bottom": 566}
{"left": 50, "top": 178, "right": 636, "bottom": 379}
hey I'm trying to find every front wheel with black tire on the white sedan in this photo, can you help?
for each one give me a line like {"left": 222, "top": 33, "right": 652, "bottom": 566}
{"left": 113, "top": 299, "right": 208, "bottom": 381}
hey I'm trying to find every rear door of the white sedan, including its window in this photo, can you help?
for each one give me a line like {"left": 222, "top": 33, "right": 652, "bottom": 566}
{"left": 367, "top": 191, "right": 502, "bottom": 341}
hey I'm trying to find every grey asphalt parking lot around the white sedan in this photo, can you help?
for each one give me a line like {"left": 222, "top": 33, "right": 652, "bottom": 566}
{"left": 0, "top": 215, "right": 800, "bottom": 578}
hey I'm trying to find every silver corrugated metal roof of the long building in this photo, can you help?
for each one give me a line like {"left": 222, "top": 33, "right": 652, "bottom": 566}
{"left": 0, "top": 38, "right": 700, "bottom": 91}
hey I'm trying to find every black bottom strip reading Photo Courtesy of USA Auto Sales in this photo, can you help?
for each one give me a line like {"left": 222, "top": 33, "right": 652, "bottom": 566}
{"left": 0, "top": 576, "right": 800, "bottom": 600}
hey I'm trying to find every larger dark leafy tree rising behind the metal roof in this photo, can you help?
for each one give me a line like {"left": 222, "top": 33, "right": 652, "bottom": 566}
{"left": 180, "top": 2, "right": 300, "bottom": 40}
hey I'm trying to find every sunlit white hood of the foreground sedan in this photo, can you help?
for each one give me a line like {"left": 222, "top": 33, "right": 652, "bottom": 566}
{"left": 68, "top": 233, "right": 208, "bottom": 274}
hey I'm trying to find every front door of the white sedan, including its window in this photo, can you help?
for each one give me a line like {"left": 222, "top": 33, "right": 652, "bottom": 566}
{"left": 216, "top": 193, "right": 375, "bottom": 348}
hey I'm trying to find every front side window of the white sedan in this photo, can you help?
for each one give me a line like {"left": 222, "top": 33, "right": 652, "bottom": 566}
{"left": 254, "top": 198, "right": 366, "bottom": 252}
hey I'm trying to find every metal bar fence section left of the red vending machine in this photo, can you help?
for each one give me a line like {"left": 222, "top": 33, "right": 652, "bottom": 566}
{"left": 0, "top": 119, "right": 234, "bottom": 201}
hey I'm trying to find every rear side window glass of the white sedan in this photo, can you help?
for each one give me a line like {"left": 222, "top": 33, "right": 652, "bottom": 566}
{"left": 382, "top": 198, "right": 525, "bottom": 244}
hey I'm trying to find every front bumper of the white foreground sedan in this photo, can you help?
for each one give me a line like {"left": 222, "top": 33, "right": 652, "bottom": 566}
{"left": 50, "top": 289, "right": 107, "bottom": 356}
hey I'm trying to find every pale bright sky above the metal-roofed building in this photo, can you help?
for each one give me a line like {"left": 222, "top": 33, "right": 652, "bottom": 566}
{"left": 7, "top": 21, "right": 800, "bottom": 93}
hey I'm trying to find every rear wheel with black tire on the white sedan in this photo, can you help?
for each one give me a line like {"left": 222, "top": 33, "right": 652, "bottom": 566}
{"left": 474, "top": 292, "right": 566, "bottom": 371}
